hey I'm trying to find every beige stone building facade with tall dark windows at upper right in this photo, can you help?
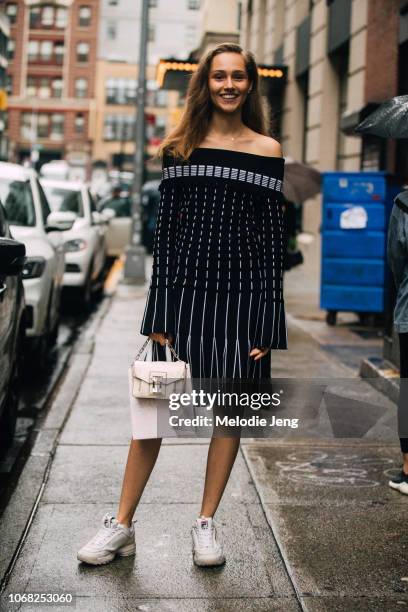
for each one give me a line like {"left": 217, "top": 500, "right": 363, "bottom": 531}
{"left": 241, "top": 0, "right": 408, "bottom": 233}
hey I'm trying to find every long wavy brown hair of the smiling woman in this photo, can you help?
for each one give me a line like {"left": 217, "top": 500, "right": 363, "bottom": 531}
{"left": 157, "top": 43, "right": 268, "bottom": 160}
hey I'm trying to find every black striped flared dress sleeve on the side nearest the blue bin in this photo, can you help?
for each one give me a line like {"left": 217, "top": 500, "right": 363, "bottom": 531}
{"left": 255, "top": 192, "right": 287, "bottom": 349}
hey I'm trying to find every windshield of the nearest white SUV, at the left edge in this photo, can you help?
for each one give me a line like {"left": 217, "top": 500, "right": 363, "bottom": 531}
{"left": 0, "top": 177, "right": 35, "bottom": 227}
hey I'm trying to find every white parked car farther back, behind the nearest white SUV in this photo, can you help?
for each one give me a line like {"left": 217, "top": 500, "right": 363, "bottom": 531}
{"left": 40, "top": 178, "right": 108, "bottom": 306}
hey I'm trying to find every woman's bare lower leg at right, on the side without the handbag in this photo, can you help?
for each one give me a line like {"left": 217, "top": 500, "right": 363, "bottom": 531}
{"left": 200, "top": 437, "right": 240, "bottom": 517}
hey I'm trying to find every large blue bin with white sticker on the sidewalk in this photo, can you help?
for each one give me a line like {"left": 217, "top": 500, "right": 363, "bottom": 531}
{"left": 320, "top": 172, "right": 401, "bottom": 325}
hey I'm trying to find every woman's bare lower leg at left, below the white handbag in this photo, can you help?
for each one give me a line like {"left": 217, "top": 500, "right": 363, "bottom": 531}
{"left": 116, "top": 438, "right": 162, "bottom": 527}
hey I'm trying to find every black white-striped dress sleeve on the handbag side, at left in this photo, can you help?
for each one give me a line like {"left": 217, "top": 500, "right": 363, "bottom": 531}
{"left": 140, "top": 162, "right": 179, "bottom": 337}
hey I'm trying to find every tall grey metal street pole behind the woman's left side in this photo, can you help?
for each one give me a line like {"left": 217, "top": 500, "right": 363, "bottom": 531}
{"left": 124, "top": 0, "right": 149, "bottom": 284}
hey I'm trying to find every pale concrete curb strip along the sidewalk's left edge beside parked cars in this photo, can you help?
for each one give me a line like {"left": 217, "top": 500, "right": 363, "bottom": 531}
{"left": 0, "top": 294, "right": 114, "bottom": 594}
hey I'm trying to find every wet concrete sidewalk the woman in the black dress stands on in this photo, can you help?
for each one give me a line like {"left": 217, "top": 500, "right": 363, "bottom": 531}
{"left": 1, "top": 251, "right": 408, "bottom": 612}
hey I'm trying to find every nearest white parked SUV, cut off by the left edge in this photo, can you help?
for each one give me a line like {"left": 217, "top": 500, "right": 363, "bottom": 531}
{"left": 0, "top": 162, "right": 69, "bottom": 363}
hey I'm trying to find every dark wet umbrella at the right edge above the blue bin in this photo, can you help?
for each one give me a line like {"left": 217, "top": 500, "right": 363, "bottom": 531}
{"left": 355, "top": 96, "right": 408, "bottom": 138}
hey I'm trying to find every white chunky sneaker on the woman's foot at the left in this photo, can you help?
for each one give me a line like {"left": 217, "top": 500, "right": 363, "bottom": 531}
{"left": 77, "top": 512, "right": 136, "bottom": 565}
